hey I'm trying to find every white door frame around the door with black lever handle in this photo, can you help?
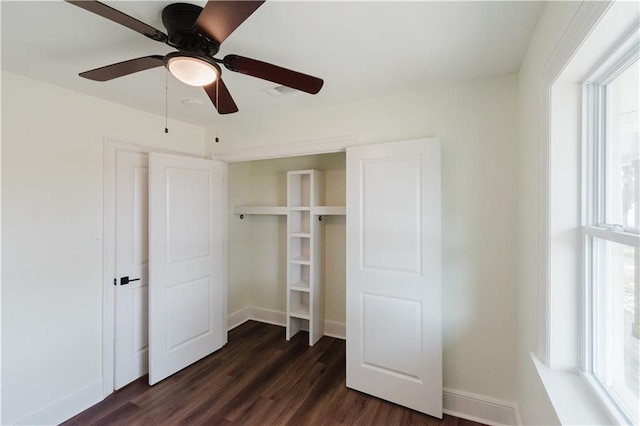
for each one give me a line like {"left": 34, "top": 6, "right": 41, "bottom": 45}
{"left": 102, "top": 138, "right": 203, "bottom": 398}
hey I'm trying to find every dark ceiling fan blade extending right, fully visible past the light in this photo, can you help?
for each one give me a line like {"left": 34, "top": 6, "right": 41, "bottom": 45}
{"left": 223, "top": 55, "right": 324, "bottom": 95}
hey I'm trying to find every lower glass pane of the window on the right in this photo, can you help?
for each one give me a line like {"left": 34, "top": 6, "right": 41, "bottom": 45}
{"left": 593, "top": 237, "right": 640, "bottom": 423}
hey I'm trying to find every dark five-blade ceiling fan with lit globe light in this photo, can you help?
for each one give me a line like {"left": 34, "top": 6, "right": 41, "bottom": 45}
{"left": 65, "top": 0, "right": 324, "bottom": 114}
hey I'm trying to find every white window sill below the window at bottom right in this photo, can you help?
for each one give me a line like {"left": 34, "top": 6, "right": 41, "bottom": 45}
{"left": 531, "top": 353, "right": 621, "bottom": 425}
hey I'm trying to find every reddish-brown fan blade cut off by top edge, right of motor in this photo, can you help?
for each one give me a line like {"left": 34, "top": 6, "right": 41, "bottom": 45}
{"left": 195, "top": 0, "right": 265, "bottom": 43}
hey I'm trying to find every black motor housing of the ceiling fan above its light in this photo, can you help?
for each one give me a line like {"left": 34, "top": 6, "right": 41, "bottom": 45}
{"left": 162, "top": 3, "right": 220, "bottom": 56}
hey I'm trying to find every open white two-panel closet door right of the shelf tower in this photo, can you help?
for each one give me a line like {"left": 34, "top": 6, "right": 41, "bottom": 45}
{"left": 347, "top": 138, "right": 442, "bottom": 418}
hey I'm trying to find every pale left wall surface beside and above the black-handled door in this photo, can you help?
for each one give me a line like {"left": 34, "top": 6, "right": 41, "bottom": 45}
{"left": 1, "top": 72, "right": 204, "bottom": 424}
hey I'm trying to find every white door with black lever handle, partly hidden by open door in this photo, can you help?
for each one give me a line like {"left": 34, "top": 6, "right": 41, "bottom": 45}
{"left": 114, "top": 151, "right": 149, "bottom": 389}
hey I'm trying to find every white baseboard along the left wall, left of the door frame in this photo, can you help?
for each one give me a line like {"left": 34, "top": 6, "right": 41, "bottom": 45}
{"left": 9, "top": 380, "right": 104, "bottom": 425}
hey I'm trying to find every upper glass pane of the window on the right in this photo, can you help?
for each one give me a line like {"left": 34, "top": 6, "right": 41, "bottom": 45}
{"left": 604, "top": 61, "right": 640, "bottom": 228}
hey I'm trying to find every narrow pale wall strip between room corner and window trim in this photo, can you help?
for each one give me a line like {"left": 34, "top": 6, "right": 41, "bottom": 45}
{"left": 517, "top": 2, "right": 580, "bottom": 424}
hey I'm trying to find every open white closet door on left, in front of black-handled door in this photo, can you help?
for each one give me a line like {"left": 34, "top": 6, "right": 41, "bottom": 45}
{"left": 149, "top": 153, "right": 227, "bottom": 385}
